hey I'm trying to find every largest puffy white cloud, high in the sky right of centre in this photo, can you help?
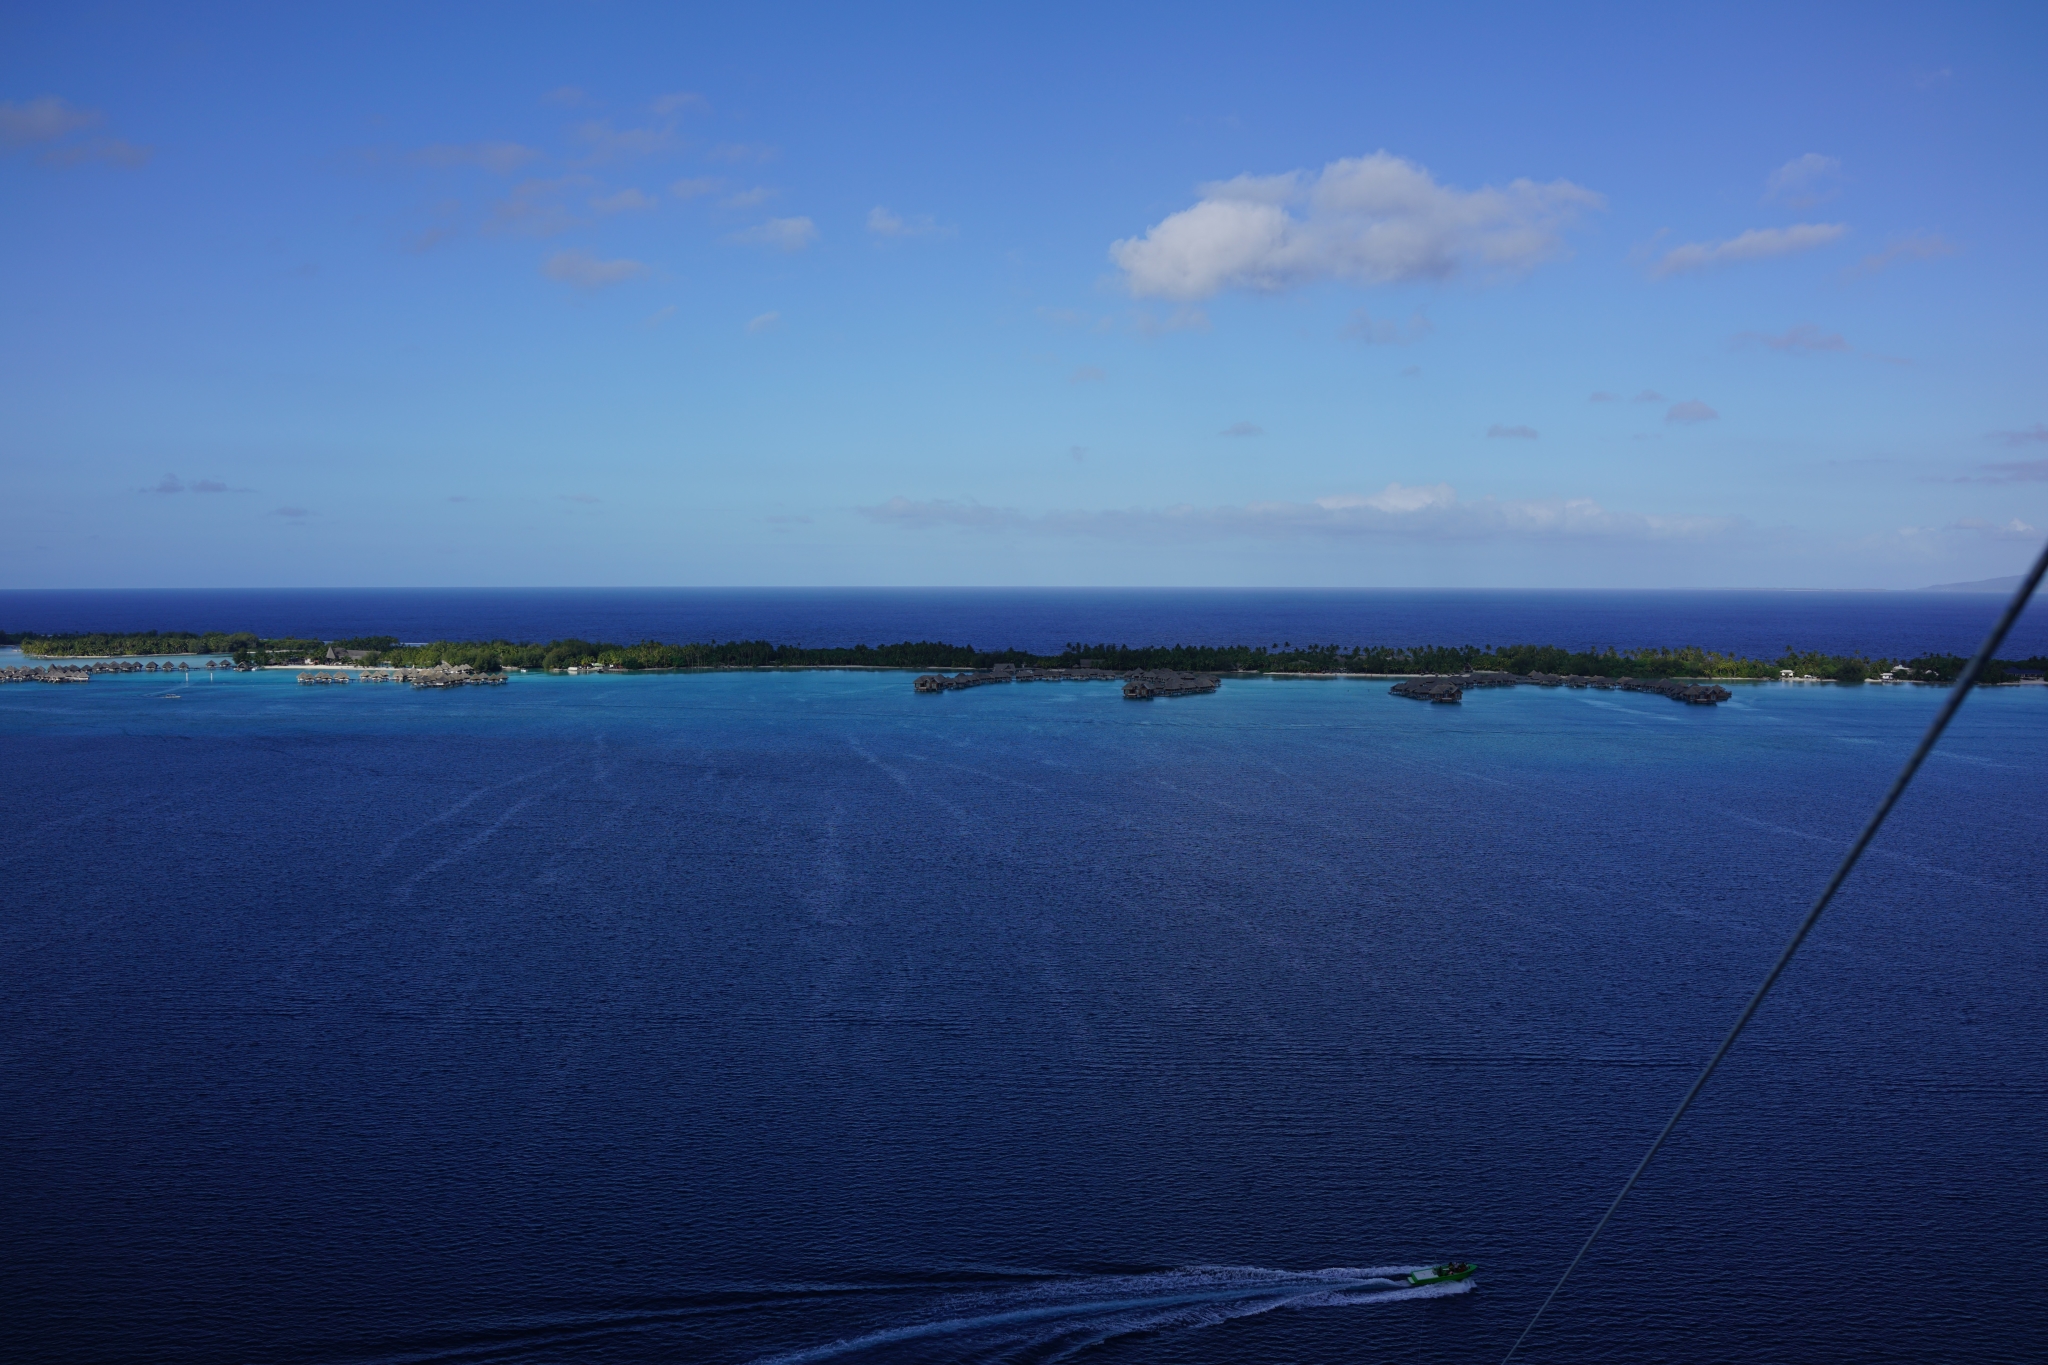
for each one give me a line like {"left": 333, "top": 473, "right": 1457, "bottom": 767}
{"left": 1110, "top": 151, "right": 1606, "bottom": 299}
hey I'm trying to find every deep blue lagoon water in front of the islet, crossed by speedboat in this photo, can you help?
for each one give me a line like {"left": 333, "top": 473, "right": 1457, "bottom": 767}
{"left": 0, "top": 658, "right": 2048, "bottom": 1365}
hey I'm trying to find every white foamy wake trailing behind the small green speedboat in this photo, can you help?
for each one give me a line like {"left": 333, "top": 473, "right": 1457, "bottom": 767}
{"left": 758, "top": 1265, "right": 1470, "bottom": 1365}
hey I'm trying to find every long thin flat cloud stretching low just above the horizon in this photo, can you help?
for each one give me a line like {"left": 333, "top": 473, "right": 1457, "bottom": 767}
{"left": 860, "top": 483, "right": 1735, "bottom": 540}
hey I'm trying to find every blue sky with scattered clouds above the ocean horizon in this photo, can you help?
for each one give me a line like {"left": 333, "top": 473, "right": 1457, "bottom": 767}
{"left": 0, "top": 4, "right": 2048, "bottom": 587}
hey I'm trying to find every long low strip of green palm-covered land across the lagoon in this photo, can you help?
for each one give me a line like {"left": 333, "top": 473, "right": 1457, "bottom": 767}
{"left": 16, "top": 630, "right": 2048, "bottom": 684}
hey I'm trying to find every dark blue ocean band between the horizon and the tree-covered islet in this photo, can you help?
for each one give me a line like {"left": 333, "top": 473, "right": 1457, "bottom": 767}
{"left": 0, "top": 587, "right": 2048, "bottom": 659}
